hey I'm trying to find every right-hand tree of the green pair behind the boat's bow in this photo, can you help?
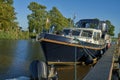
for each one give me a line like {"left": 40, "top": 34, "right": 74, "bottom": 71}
{"left": 48, "top": 7, "right": 69, "bottom": 31}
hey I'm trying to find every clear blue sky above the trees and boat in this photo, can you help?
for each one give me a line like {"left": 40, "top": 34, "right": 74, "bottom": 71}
{"left": 13, "top": 0, "right": 120, "bottom": 36}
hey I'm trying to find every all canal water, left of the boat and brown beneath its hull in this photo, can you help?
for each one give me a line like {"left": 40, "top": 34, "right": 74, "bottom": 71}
{"left": 0, "top": 40, "right": 91, "bottom": 80}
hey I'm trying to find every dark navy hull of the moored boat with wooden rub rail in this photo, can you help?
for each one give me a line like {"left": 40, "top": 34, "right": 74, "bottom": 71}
{"left": 40, "top": 36, "right": 104, "bottom": 63}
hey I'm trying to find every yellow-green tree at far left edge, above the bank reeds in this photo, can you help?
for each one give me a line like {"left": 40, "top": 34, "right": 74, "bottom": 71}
{"left": 0, "top": 0, "right": 18, "bottom": 31}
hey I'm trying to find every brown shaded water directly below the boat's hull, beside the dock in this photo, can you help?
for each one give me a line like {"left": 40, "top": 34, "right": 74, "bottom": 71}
{"left": 56, "top": 65, "right": 91, "bottom": 80}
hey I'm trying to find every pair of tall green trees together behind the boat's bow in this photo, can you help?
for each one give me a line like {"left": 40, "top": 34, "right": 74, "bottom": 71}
{"left": 27, "top": 2, "right": 69, "bottom": 33}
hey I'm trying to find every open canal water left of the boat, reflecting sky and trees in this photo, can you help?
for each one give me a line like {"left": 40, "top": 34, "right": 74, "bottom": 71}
{"left": 0, "top": 40, "right": 44, "bottom": 80}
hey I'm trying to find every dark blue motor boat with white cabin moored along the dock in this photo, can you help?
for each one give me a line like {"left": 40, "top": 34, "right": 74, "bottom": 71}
{"left": 39, "top": 20, "right": 110, "bottom": 64}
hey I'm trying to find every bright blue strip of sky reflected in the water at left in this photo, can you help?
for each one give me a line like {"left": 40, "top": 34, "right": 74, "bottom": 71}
{"left": 7, "top": 41, "right": 29, "bottom": 77}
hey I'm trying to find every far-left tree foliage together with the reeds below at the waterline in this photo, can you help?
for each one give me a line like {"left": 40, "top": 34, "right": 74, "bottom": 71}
{"left": 0, "top": 0, "right": 24, "bottom": 39}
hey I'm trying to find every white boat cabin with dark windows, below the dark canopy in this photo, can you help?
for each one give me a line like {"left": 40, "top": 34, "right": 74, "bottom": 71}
{"left": 63, "top": 28, "right": 102, "bottom": 44}
